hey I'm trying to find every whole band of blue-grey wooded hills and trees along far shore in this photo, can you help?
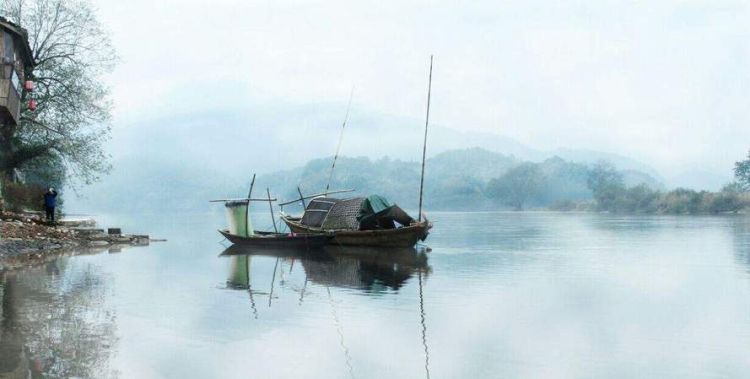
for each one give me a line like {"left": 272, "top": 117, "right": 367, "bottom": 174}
{"left": 81, "top": 148, "right": 750, "bottom": 214}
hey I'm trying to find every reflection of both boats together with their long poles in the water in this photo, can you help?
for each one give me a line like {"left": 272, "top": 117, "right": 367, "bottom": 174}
{"left": 221, "top": 245, "right": 431, "bottom": 379}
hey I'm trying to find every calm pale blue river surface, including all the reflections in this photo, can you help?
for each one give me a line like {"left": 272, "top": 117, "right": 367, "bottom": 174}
{"left": 0, "top": 212, "right": 750, "bottom": 379}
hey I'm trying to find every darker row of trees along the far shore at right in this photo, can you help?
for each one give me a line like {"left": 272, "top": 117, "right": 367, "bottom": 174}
{"left": 486, "top": 154, "right": 750, "bottom": 214}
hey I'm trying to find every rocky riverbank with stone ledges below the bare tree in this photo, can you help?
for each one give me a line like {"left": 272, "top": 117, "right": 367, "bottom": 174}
{"left": 0, "top": 211, "right": 151, "bottom": 270}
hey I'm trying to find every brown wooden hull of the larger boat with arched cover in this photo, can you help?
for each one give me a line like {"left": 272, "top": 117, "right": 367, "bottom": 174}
{"left": 281, "top": 217, "right": 432, "bottom": 247}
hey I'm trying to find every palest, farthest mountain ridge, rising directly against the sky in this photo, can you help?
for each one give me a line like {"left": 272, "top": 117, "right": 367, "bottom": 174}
{"left": 104, "top": 104, "right": 663, "bottom": 181}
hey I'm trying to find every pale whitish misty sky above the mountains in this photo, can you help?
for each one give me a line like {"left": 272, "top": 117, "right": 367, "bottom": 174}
{"left": 94, "top": 0, "right": 750, "bottom": 177}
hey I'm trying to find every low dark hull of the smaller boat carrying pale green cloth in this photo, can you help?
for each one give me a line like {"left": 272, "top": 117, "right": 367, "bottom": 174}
{"left": 219, "top": 230, "right": 333, "bottom": 249}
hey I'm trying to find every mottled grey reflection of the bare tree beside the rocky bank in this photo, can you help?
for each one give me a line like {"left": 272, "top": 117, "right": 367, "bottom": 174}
{"left": 0, "top": 258, "right": 117, "bottom": 378}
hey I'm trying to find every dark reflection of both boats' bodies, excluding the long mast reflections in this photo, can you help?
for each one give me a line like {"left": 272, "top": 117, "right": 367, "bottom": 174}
{"left": 221, "top": 245, "right": 431, "bottom": 292}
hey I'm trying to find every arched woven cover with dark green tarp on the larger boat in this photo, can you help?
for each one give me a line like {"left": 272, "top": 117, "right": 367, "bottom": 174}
{"left": 301, "top": 195, "right": 414, "bottom": 230}
